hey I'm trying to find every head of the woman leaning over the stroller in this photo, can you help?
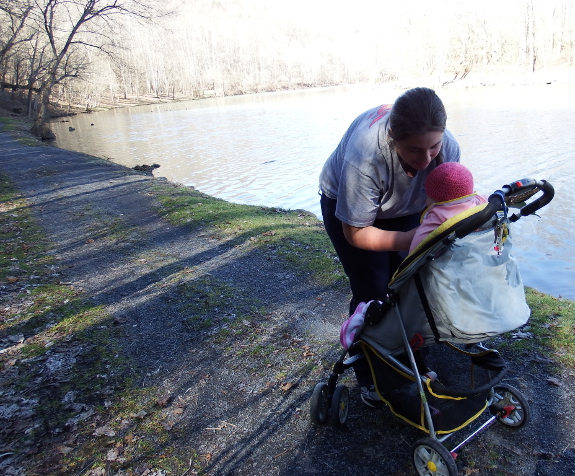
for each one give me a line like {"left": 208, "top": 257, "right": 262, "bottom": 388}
{"left": 387, "top": 88, "right": 447, "bottom": 173}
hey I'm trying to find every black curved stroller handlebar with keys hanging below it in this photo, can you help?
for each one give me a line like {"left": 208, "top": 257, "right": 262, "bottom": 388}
{"left": 454, "top": 179, "right": 555, "bottom": 238}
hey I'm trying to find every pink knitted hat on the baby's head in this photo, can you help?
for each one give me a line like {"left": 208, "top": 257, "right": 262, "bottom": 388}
{"left": 425, "top": 162, "right": 473, "bottom": 202}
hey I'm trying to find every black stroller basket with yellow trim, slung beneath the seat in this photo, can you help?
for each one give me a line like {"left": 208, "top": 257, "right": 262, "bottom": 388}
{"left": 359, "top": 341, "right": 507, "bottom": 434}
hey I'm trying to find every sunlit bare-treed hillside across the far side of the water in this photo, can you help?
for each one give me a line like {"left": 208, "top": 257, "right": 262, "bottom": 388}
{"left": 0, "top": 0, "right": 575, "bottom": 122}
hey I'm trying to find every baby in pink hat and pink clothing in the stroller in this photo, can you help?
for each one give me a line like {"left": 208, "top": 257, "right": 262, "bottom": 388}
{"left": 409, "top": 162, "right": 487, "bottom": 253}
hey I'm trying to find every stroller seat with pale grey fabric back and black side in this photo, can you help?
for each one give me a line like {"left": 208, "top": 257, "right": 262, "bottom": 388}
{"left": 362, "top": 198, "right": 530, "bottom": 353}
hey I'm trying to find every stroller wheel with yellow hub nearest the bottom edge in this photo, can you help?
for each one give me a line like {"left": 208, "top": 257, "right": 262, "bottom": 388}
{"left": 411, "top": 438, "right": 457, "bottom": 476}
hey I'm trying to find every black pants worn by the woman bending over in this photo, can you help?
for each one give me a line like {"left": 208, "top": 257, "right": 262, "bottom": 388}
{"left": 320, "top": 195, "right": 420, "bottom": 387}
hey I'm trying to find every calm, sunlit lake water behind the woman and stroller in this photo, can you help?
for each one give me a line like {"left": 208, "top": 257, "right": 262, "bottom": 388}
{"left": 51, "top": 84, "right": 575, "bottom": 300}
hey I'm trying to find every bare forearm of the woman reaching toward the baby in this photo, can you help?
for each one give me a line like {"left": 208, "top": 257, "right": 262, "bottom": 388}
{"left": 342, "top": 223, "right": 417, "bottom": 251}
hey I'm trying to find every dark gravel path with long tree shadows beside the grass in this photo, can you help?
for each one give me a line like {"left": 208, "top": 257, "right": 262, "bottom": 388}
{"left": 0, "top": 133, "right": 575, "bottom": 476}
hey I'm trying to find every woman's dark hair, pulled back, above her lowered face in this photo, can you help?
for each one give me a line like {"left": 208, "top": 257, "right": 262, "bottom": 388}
{"left": 387, "top": 88, "right": 447, "bottom": 145}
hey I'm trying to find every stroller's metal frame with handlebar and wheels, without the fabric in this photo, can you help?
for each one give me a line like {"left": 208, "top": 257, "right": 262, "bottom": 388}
{"left": 310, "top": 179, "right": 554, "bottom": 476}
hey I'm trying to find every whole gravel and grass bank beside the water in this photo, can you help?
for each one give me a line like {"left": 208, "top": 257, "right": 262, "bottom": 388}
{"left": 0, "top": 116, "right": 575, "bottom": 476}
